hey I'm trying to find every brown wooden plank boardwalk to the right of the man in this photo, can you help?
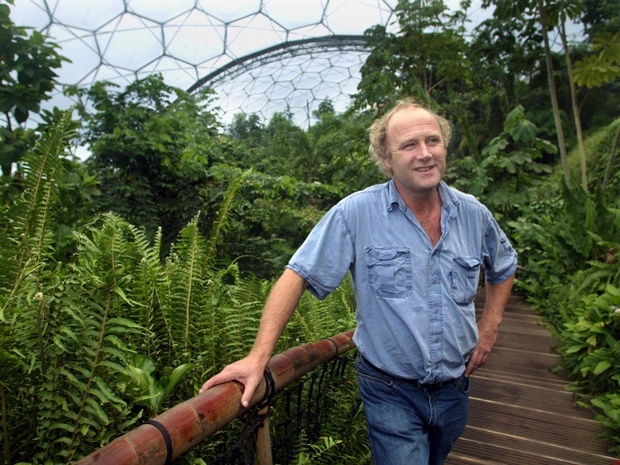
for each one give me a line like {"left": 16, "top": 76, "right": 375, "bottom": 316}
{"left": 446, "top": 296, "right": 620, "bottom": 465}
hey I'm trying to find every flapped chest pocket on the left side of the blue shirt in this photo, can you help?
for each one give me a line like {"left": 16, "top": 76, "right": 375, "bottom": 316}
{"left": 366, "top": 247, "right": 413, "bottom": 299}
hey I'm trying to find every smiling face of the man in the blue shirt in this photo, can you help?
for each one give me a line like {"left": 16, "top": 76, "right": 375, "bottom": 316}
{"left": 386, "top": 107, "right": 446, "bottom": 197}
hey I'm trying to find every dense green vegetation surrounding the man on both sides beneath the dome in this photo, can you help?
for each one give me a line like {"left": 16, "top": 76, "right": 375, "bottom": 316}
{"left": 0, "top": 0, "right": 620, "bottom": 464}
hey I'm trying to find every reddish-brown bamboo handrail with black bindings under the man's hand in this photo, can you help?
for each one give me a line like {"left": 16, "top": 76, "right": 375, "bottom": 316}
{"left": 75, "top": 330, "right": 355, "bottom": 465}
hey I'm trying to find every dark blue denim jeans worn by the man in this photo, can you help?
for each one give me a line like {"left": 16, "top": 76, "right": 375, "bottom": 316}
{"left": 357, "top": 357, "right": 469, "bottom": 465}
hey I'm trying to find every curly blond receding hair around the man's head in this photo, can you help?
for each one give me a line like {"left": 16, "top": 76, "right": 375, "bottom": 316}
{"left": 368, "top": 97, "right": 452, "bottom": 177}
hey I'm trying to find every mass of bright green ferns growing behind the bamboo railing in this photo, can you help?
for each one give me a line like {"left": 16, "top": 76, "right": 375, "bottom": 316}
{"left": 0, "top": 112, "right": 353, "bottom": 463}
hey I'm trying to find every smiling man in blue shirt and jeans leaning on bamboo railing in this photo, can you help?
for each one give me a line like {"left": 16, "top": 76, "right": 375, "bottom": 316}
{"left": 201, "top": 96, "right": 517, "bottom": 465}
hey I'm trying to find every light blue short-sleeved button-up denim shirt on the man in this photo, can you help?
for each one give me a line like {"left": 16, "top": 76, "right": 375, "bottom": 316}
{"left": 287, "top": 181, "right": 517, "bottom": 383}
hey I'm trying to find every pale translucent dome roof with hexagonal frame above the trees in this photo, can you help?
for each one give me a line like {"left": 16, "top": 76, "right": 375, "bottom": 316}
{"left": 11, "top": 0, "right": 397, "bottom": 124}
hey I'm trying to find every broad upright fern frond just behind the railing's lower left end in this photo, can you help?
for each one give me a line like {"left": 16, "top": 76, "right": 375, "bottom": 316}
{"left": 55, "top": 215, "right": 149, "bottom": 459}
